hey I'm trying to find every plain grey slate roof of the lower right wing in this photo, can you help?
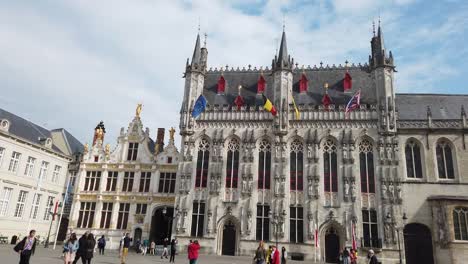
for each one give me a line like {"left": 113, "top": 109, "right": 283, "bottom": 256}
{"left": 395, "top": 94, "right": 468, "bottom": 120}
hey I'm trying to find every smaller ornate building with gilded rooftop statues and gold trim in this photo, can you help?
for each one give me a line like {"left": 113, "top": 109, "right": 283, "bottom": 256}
{"left": 70, "top": 105, "right": 180, "bottom": 249}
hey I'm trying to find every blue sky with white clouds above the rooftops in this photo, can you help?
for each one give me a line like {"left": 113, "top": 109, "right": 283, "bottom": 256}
{"left": 0, "top": 0, "right": 468, "bottom": 144}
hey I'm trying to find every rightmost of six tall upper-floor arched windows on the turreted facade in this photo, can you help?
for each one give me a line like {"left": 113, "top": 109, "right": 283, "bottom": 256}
{"left": 359, "top": 139, "right": 375, "bottom": 193}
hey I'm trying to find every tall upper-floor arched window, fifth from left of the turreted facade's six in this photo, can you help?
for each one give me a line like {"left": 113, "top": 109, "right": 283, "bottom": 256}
{"left": 323, "top": 139, "right": 338, "bottom": 192}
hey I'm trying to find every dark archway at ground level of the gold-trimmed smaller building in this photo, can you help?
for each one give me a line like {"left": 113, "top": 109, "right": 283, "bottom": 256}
{"left": 149, "top": 207, "right": 174, "bottom": 245}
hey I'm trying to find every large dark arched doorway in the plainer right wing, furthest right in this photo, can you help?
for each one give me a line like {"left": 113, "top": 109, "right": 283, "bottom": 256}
{"left": 403, "top": 223, "right": 434, "bottom": 264}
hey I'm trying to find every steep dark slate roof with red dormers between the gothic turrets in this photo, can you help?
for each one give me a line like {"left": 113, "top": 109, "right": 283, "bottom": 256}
{"left": 199, "top": 64, "right": 377, "bottom": 106}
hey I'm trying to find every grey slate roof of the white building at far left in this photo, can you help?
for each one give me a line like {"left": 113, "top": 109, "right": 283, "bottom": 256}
{"left": 0, "top": 108, "right": 81, "bottom": 155}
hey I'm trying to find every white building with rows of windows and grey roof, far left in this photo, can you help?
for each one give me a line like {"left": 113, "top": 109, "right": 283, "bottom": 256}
{"left": 0, "top": 109, "right": 82, "bottom": 242}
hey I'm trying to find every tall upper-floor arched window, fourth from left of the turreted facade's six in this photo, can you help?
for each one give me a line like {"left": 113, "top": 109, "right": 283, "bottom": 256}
{"left": 289, "top": 139, "right": 304, "bottom": 191}
